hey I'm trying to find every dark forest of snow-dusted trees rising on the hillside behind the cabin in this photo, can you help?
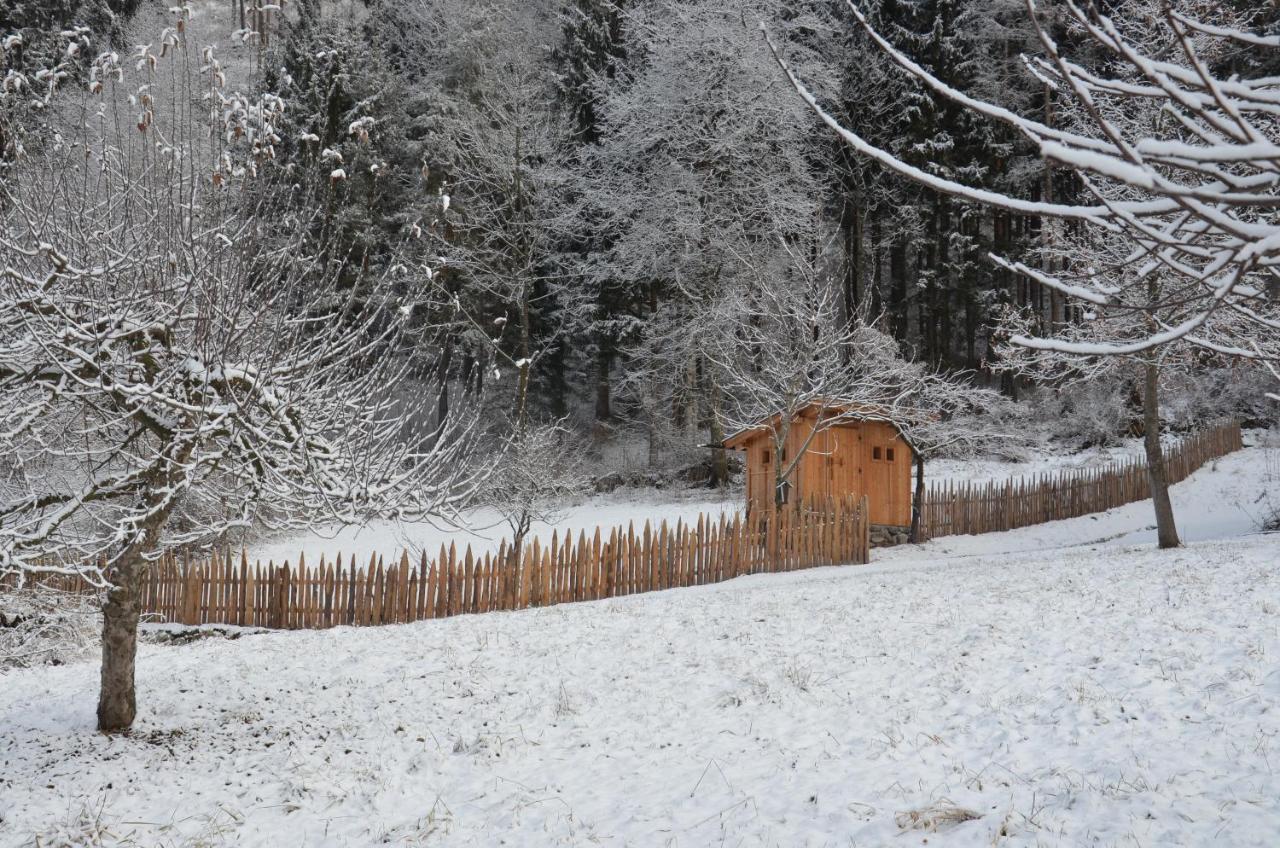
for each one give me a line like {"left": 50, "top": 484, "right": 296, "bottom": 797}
{"left": 0, "top": 0, "right": 1276, "bottom": 471}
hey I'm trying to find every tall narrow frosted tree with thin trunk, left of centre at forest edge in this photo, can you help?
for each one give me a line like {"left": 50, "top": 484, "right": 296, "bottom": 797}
{"left": 378, "top": 0, "right": 573, "bottom": 428}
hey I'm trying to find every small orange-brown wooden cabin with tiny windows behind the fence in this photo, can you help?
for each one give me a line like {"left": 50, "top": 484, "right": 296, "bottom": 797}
{"left": 724, "top": 404, "right": 915, "bottom": 528}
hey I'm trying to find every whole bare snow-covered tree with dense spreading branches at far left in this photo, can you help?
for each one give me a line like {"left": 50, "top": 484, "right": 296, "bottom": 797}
{"left": 0, "top": 18, "right": 476, "bottom": 731}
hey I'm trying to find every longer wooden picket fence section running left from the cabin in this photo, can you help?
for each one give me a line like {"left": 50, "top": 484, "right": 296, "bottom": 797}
{"left": 7, "top": 498, "right": 870, "bottom": 629}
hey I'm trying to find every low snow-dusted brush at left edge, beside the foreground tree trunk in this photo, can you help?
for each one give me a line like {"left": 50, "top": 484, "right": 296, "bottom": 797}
{"left": 0, "top": 585, "right": 99, "bottom": 669}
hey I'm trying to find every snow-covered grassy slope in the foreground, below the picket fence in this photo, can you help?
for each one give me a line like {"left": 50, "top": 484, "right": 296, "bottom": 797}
{"left": 0, "top": 450, "right": 1280, "bottom": 847}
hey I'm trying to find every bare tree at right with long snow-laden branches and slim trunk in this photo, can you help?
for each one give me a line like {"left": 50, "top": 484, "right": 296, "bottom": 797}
{"left": 765, "top": 0, "right": 1280, "bottom": 547}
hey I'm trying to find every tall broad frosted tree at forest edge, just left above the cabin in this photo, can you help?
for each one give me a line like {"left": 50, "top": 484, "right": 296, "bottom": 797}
{"left": 584, "top": 0, "right": 822, "bottom": 485}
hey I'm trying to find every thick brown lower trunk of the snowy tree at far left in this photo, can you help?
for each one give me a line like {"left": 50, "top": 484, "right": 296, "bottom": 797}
{"left": 97, "top": 548, "right": 146, "bottom": 733}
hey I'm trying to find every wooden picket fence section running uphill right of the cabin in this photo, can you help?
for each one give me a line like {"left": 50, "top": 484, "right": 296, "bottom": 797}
{"left": 920, "top": 421, "right": 1244, "bottom": 539}
